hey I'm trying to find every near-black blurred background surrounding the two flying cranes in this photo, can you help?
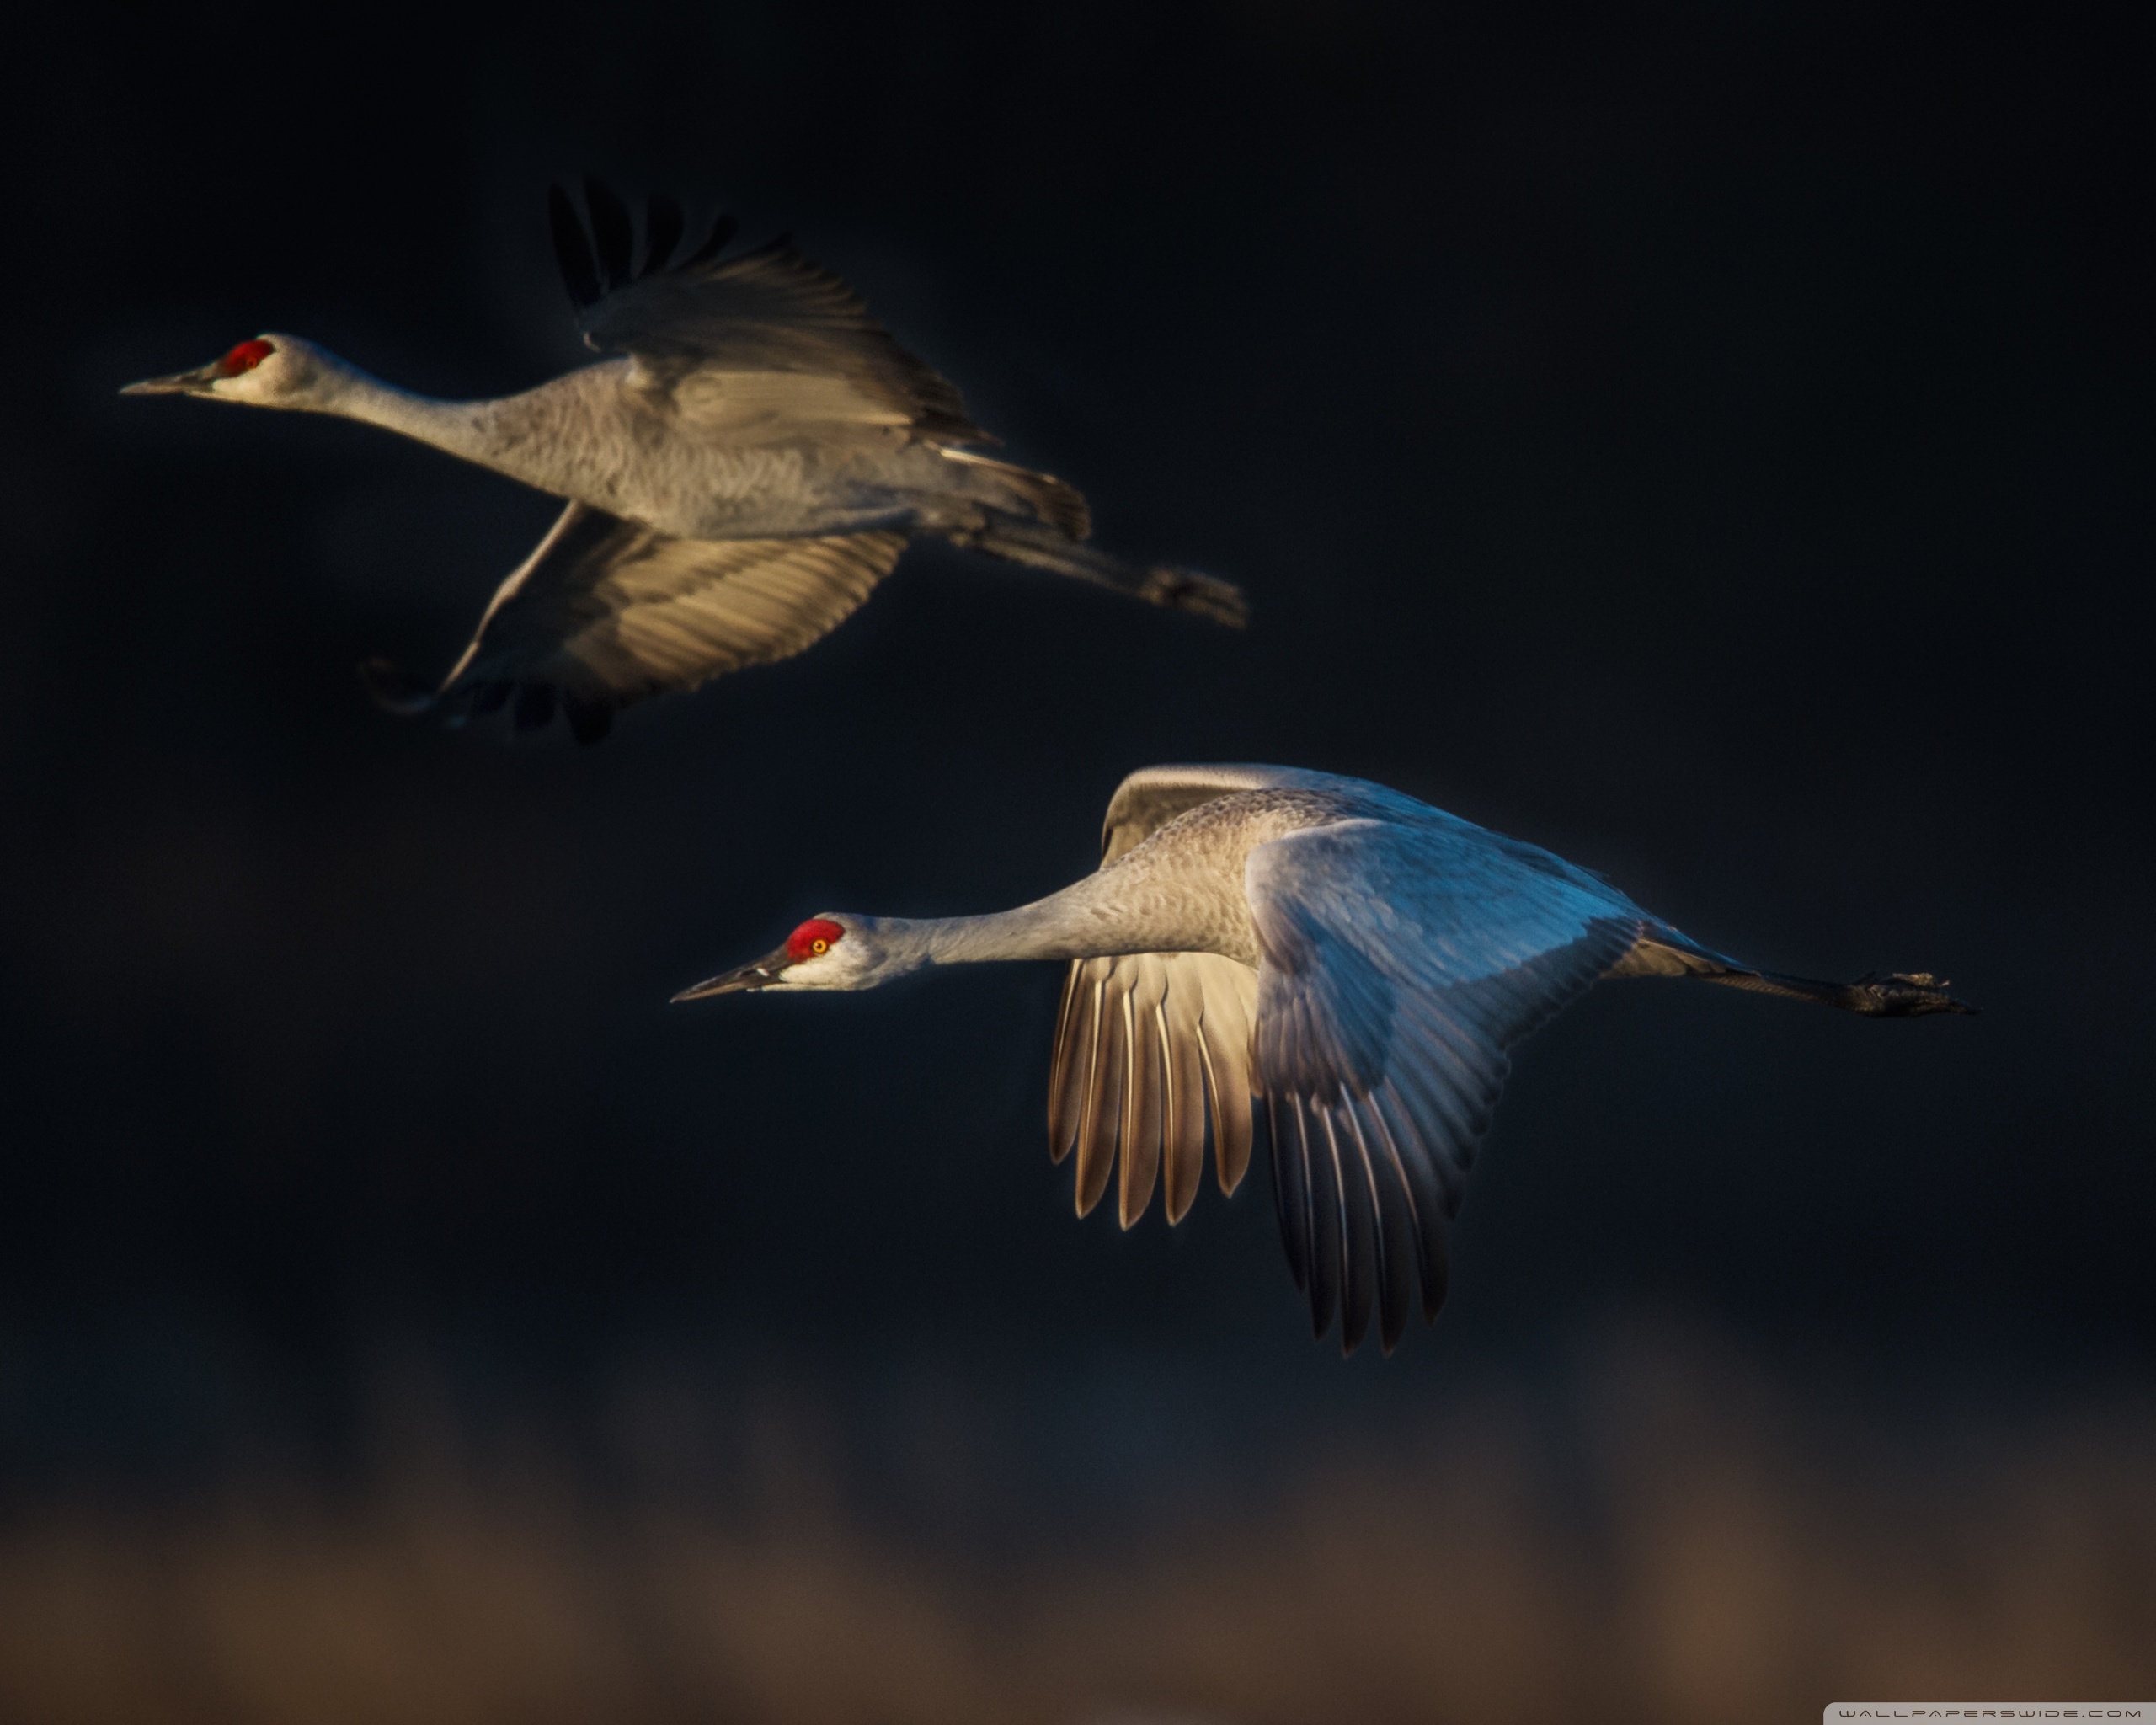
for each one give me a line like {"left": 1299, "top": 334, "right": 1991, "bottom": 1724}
{"left": 0, "top": 0, "right": 2156, "bottom": 1717}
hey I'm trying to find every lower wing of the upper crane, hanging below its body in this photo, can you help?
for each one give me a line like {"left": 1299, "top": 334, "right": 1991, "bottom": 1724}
{"left": 366, "top": 502, "right": 905, "bottom": 742}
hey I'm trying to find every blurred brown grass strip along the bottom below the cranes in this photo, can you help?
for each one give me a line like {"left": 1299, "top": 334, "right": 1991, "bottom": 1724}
{"left": 0, "top": 1326, "right": 2156, "bottom": 1725}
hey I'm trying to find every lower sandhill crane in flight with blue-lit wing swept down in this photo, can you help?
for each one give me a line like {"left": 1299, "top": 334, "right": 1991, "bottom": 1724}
{"left": 675, "top": 766, "right": 1972, "bottom": 1352}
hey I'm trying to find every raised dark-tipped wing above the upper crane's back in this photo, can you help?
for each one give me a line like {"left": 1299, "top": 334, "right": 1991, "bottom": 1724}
{"left": 550, "top": 179, "right": 994, "bottom": 444}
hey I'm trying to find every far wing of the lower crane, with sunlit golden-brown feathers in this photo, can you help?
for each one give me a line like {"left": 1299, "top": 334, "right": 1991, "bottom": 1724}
{"left": 1048, "top": 766, "right": 1313, "bottom": 1227}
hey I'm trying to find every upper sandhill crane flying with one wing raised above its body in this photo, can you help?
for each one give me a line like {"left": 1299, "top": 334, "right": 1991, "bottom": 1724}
{"left": 123, "top": 181, "right": 1244, "bottom": 742}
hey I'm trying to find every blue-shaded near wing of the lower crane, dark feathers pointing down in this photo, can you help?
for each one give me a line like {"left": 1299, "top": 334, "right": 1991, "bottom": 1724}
{"left": 1244, "top": 811, "right": 1652, "bottom": 1352}
